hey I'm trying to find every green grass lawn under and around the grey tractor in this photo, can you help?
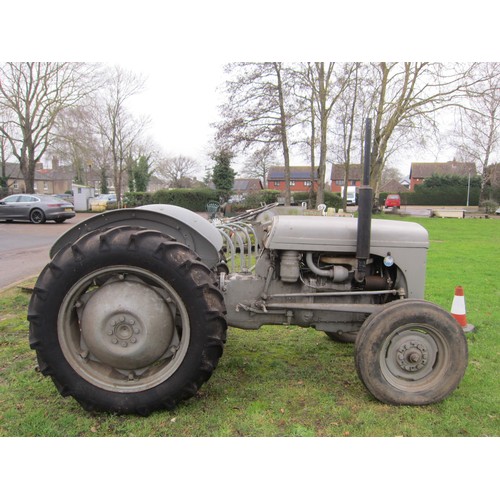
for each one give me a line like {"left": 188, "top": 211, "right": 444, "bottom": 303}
{"left": 0, "top": 218, "right": 500, "bottom": 437}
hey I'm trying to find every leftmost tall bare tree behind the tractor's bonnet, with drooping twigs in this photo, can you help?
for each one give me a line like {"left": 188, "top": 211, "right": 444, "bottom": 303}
{"left": 216, "top": 62, "right": 296, "bottom": 205}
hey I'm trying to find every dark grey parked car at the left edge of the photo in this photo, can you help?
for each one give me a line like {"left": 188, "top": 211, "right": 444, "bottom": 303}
{"left": 0, "top": 194, "right": 76, "bottom": 224}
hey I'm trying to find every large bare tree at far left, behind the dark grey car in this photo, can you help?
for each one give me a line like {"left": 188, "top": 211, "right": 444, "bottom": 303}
{"left": 0, "top": 62, "right": 93, "bottom": 192}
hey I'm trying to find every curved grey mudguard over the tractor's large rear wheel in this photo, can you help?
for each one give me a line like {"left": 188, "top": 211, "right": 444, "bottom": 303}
{"left": 50, "top": 205, "right": 222, "bottom": 268}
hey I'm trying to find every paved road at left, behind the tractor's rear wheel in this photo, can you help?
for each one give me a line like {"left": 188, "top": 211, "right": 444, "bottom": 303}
{"left": 0, "top": 214, "right": 91, "bottom": 291}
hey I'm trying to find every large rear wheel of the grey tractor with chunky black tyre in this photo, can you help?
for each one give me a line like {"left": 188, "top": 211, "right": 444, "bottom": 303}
{"left": 28, "top": 227, "right": 227, "bottom": 415}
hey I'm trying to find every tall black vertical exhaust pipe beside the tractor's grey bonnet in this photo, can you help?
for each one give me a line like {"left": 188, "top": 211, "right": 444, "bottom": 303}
{"left": 354, "top": 118, "right": 373, "bottom": 286}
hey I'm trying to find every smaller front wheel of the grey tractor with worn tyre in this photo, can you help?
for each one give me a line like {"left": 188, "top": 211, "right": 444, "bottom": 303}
{"left": 355, "top": 299, "right": 468, "bottom": 405}
